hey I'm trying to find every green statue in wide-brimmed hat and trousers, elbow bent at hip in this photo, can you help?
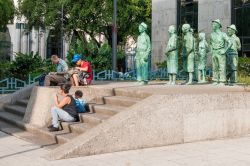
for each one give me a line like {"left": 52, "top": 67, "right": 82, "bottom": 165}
{"left": 210, "top": 19, "right": 232, "bottom": 85}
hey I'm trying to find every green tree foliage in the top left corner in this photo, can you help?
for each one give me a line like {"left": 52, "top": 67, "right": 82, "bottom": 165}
{"left": 0, "top": 0, "right": 15, "bottom": 31}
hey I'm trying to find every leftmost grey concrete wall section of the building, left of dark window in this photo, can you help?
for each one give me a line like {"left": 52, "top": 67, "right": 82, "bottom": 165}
{"left": 152, "top": 0, "right": 177, "bottom": 69}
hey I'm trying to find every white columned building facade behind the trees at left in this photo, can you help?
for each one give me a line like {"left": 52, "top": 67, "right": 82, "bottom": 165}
{"left": 0, "top": 0, "right": 70, "bottom": 60}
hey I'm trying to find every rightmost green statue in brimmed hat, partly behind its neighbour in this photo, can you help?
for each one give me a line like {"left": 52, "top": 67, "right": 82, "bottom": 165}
{"left": 227, "top": 25, "right": 241, "bottom": 85}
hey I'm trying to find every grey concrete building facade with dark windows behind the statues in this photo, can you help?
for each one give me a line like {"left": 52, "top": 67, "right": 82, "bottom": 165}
{"left": 152, "top": 0, "right": 250, "bottom": 69}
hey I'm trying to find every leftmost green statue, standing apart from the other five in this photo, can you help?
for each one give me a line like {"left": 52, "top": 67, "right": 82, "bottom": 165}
{"left": 135, "top": 23, "right": 151, "bottom": 85}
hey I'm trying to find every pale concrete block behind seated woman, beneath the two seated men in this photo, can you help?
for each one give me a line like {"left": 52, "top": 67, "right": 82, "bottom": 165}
{"left": 23, "top": 86, "right": 114, "bottom": 127}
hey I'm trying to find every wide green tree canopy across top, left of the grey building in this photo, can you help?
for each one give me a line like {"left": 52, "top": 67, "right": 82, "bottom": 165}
{"left": 19, "top": 0, "right": 151, "bottom": 47}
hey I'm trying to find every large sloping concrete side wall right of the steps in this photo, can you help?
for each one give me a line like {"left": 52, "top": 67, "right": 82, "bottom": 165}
{"left": 47, "top": 92, "right": 250, "bottom": 159}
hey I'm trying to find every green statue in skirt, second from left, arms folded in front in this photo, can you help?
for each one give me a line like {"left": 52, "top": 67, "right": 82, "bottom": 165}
{"left": 165, "top": 25, "right": 178, "bottom": 85}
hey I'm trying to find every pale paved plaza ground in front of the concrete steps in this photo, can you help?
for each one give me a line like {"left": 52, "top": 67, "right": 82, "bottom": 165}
{"left": 0, "top": 132, "right": 250, "bottom": 166}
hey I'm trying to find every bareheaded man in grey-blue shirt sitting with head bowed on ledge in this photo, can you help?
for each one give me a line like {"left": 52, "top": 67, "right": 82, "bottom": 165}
{"left": 44, "top": 55, "right": 69, "bottom": 86}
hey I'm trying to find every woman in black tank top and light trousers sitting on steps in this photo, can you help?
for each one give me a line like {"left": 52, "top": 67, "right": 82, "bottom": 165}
{"left": 48, "top": 84, "right": 78, "bottom": 132}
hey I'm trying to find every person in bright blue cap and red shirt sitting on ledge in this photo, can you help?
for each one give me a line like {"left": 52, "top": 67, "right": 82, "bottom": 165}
{"left": 71, "top": 54, "right": 93, "bottom": 86}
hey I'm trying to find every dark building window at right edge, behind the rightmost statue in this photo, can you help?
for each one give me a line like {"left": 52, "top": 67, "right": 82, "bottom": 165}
{"left": 232, "top": 0, "right": 250, "bottom": 57}
